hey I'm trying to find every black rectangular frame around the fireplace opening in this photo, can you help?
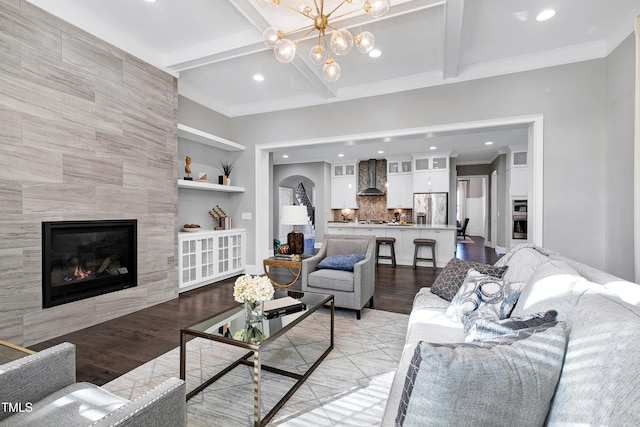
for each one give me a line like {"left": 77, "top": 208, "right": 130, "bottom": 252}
{"left": 42, "top": 219, "right": 138, "bottom": 308}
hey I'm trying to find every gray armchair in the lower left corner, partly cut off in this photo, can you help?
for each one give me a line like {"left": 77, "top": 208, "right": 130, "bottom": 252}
{"left": 0, "top": 343, "right": 187, "bottom": 427}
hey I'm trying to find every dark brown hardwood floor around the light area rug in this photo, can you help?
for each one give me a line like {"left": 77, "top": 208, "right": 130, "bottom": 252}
{"left": 30, "top": 236, "right": 498, "bottom": 385}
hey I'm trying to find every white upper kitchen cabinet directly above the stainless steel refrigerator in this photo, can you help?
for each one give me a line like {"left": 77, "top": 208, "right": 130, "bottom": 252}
{"left": 413, "top": 153, "right": 450, "bottom": 193}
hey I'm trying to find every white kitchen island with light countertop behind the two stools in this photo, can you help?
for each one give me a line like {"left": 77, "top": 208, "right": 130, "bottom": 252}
{"left": 326, "top": 222, "right": 458, "bottom": 268}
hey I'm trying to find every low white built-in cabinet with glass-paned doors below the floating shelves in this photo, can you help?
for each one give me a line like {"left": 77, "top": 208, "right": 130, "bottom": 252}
{"left": 178, "top": 229, "right": 246, "bottom": 292}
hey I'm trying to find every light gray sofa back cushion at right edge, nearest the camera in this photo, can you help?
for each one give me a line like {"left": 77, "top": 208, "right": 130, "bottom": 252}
{"left": 548, "top": 290, "right": 640, "bottom": 426}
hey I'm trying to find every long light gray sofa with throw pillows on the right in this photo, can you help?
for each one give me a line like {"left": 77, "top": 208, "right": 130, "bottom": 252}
{"left": 382, "top": 244, "right": 640, "bottom": 427}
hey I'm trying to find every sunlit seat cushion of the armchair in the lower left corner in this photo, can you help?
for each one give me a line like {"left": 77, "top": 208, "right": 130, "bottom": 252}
{"left": 5, "top": 382, "right": 129, "bottom": 427}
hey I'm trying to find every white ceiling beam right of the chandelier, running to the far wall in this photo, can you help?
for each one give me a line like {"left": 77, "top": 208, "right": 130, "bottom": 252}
{"left": 442, "top": 0, "right": 465, "bottom": 80}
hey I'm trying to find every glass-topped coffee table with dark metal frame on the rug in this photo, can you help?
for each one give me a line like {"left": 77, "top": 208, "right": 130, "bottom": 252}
{"left": 180, "top": 289, "right": 335, "bottom": 427}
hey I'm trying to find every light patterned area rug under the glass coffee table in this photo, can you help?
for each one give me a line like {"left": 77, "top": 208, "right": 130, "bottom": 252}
{"left": 104, "top": 308, "right": 409, "bottom": 427}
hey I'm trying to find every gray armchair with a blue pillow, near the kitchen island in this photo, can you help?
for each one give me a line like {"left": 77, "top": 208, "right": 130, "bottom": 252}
{"left": 301, "top": 234, "right": 376, "bottom": 319}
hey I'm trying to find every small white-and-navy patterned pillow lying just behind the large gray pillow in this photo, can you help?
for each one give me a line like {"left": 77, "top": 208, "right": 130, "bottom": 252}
{"left": 463, "top": 310, "right": 558, "bottom": 342}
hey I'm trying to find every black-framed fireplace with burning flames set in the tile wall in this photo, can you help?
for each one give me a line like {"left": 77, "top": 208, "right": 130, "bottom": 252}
{"left": 42, "top": 219, "right": 138, "bottom": 308}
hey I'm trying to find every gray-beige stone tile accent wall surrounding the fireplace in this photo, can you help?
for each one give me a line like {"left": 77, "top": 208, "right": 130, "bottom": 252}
{"left": 0, "top": 0, "right": 178, "bottom": 345}
